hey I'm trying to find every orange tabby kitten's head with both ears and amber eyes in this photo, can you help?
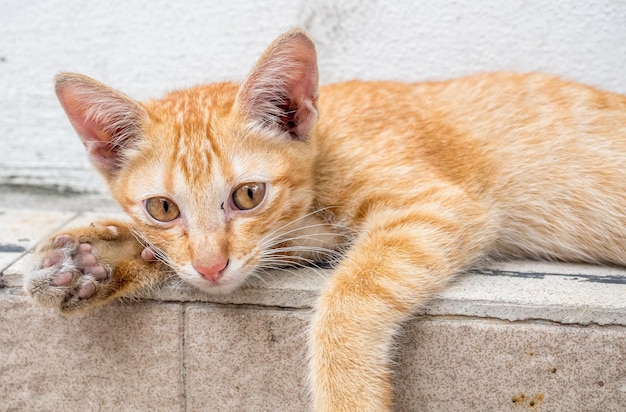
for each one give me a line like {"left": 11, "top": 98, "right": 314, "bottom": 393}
{"left": 56, "top": 30, "right": 318, "bottom": 293}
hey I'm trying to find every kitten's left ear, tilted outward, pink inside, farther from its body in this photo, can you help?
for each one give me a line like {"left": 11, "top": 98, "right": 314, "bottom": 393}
{"left": 55, "top": 73, "right": 148, "bottom": 176}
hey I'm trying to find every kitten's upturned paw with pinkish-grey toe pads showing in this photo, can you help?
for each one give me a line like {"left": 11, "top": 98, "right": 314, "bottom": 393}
{"left": 25, "top": 225, "right": 119, "bottom": 312}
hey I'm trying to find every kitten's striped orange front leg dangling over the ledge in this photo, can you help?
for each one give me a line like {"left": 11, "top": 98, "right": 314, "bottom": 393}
{"left": 309, "top": 195, "right": 492, "bottom": 412}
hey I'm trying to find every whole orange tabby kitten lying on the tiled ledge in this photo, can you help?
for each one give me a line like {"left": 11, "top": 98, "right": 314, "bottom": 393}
{"left": 25, "top": 29, "right": 626, "bottom": 411}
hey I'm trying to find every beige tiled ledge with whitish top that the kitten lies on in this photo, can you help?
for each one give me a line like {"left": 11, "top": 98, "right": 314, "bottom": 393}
{"left": 0, "top": 187, "right": 626, "bottom": 411}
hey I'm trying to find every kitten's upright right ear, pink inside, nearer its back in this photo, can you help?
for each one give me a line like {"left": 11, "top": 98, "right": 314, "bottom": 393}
{"left": 236, "top": 30, "right": 319, "bottom": 140}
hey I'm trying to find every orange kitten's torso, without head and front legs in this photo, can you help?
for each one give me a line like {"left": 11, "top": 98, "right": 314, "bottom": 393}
{"left": 314, "top": 73, "right": 626, "bottom": 264}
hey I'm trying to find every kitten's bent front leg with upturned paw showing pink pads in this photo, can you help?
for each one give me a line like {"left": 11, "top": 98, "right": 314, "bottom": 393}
{"left": 24, "top": 221, "right": 167, "bottom": 313}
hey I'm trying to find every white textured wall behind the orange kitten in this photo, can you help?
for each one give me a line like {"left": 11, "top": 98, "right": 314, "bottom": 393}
{"left": 0, "top": 0, "right": 626, "bottom": 190}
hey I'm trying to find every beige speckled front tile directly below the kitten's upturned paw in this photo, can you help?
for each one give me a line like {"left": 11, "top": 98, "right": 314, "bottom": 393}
{"left": 0, "top": 290, "right": 185, "bottom": 411}
